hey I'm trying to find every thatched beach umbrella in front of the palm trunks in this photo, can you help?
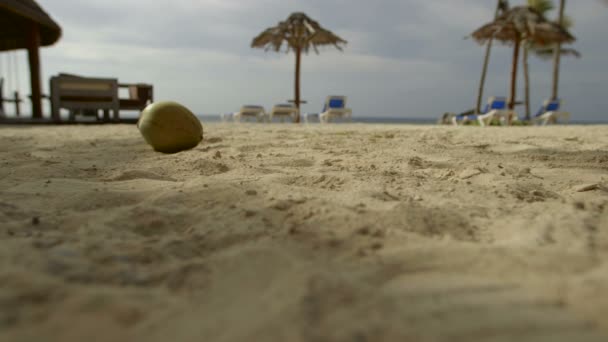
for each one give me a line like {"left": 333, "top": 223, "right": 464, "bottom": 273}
{"left": 472, "top": 6, "right": 575, "bottom": 109}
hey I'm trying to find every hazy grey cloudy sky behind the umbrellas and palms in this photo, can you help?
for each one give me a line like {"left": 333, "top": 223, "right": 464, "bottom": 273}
{"left": 0, "top": 0, "right": 608, "bottom": 121}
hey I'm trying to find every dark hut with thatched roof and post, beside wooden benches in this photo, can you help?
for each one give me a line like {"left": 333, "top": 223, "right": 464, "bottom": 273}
{"left": 0, "top": 0, "right": 61, "bottom": 118}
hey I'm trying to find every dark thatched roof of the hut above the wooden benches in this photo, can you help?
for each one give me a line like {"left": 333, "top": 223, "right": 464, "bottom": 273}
{"left": 0, "top": 0, "right": 61, "bottom": 51}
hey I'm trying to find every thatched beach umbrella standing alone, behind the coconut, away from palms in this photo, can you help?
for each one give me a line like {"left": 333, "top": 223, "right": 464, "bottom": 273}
{"left": 251, "top": 12, "right": 346, "bottom": 122}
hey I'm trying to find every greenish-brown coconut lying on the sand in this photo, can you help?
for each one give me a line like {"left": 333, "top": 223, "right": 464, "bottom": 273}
{"left": 137, "top": 101, "right": 203, "bottom": 153}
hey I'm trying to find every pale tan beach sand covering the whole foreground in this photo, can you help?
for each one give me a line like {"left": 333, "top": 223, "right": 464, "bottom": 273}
{"left": 0, "top": 123, "right": 608, "bottom": 342}
